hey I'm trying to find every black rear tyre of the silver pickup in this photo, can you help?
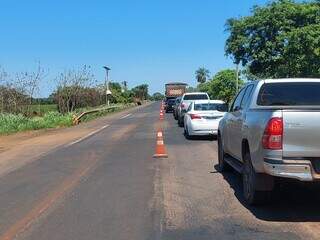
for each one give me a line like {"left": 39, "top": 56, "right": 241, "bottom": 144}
{"left": 242, "top": 153, "right": 272, "bottom": 205}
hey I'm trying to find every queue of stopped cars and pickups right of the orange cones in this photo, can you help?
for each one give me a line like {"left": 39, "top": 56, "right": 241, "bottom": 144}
{"left": 165, "top": 79, "right": 320, "bottom": 205}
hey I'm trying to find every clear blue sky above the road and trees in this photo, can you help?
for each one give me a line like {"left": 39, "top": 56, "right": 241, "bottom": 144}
{"left": 0, "top": 0, "right": 267, "bottom": 96}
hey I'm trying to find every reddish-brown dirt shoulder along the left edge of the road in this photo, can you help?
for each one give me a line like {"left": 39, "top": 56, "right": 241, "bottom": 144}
{"left": 0, "top": 103, "right": 150, "bottom": 176}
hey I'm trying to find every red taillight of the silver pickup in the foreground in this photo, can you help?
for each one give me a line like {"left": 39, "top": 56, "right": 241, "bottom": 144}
{"left": 262, "top": 117, "right": 283, "bottom": 150}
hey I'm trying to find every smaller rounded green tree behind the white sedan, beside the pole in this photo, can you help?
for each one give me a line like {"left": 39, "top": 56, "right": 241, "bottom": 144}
{"left": 199, "top": 69, "right": 243, "bottom": 103}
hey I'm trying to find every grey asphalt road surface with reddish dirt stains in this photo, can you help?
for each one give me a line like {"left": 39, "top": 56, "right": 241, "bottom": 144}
{"left": 0, "top": 103, "right": 320, "bottom": 240}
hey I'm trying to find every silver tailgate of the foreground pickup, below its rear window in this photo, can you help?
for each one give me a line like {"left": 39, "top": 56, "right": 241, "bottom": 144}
{"left": 283, "top": 110, "right": 320, "bottom": 158}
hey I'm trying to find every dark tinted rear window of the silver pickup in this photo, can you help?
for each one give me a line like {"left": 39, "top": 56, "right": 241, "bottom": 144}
{"left": 257, "top": 82, "right": 320, "bottom": 106}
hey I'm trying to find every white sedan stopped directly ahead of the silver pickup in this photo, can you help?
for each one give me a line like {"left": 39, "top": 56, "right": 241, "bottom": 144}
{"left": 184, "top": 100, "right": 228, "bottom": 138}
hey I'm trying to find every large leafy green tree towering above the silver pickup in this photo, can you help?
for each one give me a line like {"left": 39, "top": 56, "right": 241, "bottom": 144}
{"left": 226, "top": 0, "right": 320, "bottom": 78}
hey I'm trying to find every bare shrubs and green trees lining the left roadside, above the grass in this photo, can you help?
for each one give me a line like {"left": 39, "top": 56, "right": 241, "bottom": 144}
{"left": 0, "top": 63, "right": 150, "bottom": 115}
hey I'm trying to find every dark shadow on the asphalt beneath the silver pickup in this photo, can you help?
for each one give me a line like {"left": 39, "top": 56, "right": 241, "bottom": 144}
{"left": 215, "top": 165, "right": 320, "bottom": 222}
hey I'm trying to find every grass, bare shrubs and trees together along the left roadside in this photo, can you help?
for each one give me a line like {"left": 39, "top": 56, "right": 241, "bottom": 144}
{"left": 0, "top": 63, "right": 152, "bottom": 134}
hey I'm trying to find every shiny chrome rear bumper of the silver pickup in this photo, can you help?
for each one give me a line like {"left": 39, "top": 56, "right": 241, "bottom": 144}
{"left": 264, "top": 158, "right": 320, "bottom": 182}
